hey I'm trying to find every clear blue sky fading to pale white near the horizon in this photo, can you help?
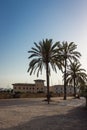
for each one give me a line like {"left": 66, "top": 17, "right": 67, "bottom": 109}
{"left": 0, "top": 0, "right": 87, "bottom": 88}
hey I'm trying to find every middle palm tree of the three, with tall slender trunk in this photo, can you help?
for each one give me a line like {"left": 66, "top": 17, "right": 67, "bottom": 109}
{"left": 58, "top": 41, "right": 81, "bottom": 100}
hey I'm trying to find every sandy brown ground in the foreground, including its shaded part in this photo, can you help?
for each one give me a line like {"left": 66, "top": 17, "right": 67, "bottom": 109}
{"left": 0, "top": 98, "right": 87, "bottom": 130}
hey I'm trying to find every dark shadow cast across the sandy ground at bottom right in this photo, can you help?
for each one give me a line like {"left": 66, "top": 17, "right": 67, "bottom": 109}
{"left": 0, "top": 106, "right": 87, "bottom": 130}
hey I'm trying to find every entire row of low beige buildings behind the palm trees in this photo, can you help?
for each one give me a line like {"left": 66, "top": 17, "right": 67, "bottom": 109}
{"left": 13, "top": 79, "right": 74, "bottom": 95}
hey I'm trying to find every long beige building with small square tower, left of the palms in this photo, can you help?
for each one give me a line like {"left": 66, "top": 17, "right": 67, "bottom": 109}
{"left": 12, "top": 79, "right": 45, "bottom": 93}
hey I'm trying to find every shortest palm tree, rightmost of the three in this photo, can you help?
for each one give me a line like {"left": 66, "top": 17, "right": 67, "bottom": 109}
{"left": 67, "top": 61, "right": 87, "bottom": 97}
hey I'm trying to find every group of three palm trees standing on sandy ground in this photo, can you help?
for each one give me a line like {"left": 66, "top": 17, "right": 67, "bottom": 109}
{"left": 28, "top": 39, "right": 87, "bottom": 104}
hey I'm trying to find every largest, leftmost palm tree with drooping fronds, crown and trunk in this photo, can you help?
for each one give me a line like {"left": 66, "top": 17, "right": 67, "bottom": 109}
{"left": 28, "top": 39, "right": 61, "bottom": 104}
